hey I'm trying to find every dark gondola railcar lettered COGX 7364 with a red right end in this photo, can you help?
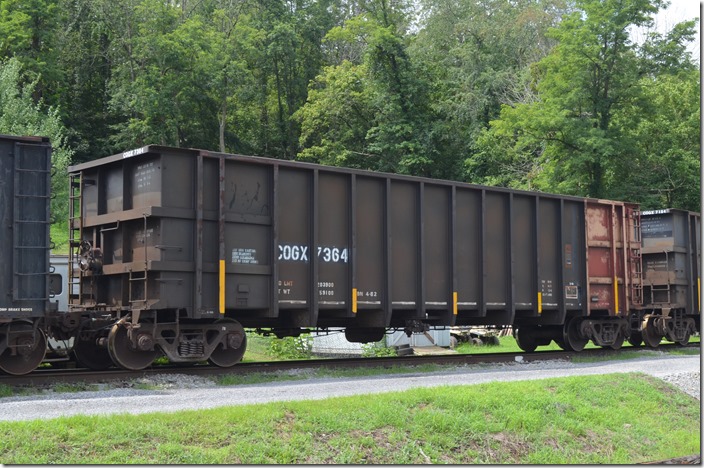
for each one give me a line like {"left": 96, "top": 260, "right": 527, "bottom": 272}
{"left": 69, "top": 145, "right": 641, "bottom": 369}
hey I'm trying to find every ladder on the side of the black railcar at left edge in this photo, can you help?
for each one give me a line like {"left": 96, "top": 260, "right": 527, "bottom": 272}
{"left": 12, "top": 145, "right": 51, "bottom": 301}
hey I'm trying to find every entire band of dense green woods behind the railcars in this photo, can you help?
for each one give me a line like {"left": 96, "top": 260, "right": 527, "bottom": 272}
{"left": 0, "top": 0, "right": 700, "bottom": 234}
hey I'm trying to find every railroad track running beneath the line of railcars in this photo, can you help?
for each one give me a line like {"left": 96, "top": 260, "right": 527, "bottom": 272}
{"left": 0, "top": 343, "right": 700, "bottom": 387}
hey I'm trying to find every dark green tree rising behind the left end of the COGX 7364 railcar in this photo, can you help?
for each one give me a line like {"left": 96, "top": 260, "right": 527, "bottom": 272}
{"left": 110, "top": 0, "right": 218, "bottom": 148}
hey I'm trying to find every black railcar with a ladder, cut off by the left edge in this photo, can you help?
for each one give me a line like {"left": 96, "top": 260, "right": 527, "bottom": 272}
{"left": 0, "top": 135, "right": 52, "bottom": 374}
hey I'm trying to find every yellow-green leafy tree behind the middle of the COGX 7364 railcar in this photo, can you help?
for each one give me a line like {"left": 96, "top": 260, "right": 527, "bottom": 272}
{"left": 295, "top": 0, "right": 444, "bottom": 177}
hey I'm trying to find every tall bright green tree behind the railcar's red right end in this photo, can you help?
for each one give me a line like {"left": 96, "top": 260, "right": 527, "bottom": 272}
{"left": 476, "top": 0, "right": 689, "bottom": 201}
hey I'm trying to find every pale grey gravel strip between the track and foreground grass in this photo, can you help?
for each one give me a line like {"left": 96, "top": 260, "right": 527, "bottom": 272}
{"left": 0, "top": 354, "right": 701, "bottom": 421}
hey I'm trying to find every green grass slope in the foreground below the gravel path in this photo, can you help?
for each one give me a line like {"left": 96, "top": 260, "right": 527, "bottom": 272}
{"left": 0, "top": 374, "right": 700, "bottom": 464}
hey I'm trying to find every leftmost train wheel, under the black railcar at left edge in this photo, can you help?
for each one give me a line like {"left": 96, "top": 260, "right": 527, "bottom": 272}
{"left": 0, "top": 323, "right": 46, "bottom": 375}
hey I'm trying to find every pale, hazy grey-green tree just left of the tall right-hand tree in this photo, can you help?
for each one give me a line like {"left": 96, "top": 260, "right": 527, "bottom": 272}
{"left": 411, "top": 0, "right": 566, "bottom": 181}
